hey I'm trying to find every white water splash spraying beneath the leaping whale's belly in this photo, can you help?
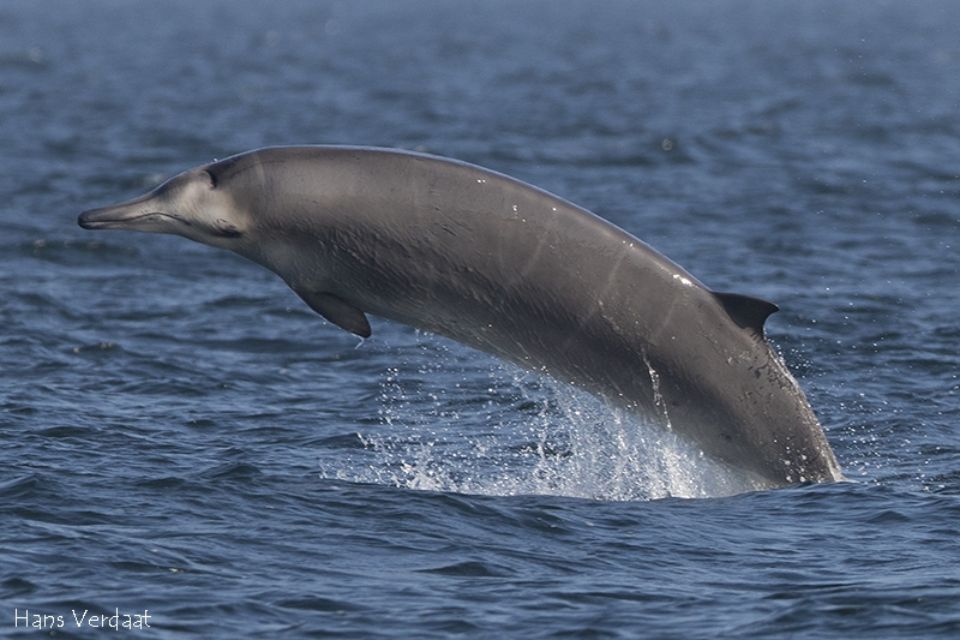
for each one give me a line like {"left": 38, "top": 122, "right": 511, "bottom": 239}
{"left": 334, "top": 344, "right": 758, "bottom": 500}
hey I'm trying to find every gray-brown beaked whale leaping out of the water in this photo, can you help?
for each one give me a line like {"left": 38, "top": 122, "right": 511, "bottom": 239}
{"left": 79, "top": 146, "right": 842, "bottom": 488}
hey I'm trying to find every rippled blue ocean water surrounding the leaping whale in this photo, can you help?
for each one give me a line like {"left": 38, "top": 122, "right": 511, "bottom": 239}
{"left": 0, "top": 0, "right": 960, "bottom": 639}
